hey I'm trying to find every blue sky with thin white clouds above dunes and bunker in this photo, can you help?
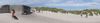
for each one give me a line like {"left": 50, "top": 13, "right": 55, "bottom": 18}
{"left": 0, "top": 0, "right": 100, "bottom": 10}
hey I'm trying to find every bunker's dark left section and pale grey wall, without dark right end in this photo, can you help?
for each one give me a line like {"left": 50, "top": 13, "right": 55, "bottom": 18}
{"left": 0, "top": 5, "right": 31, "bottom": 13}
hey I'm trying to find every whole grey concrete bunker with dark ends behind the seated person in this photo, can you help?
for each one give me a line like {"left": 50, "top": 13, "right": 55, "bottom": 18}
{"left": 0, "top": 5, "right": 31, "bottom": 13}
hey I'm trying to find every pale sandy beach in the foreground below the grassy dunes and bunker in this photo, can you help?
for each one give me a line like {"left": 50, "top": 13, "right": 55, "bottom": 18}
{"left": 0, "top": 11, "right": 100, "bottom": 23}
